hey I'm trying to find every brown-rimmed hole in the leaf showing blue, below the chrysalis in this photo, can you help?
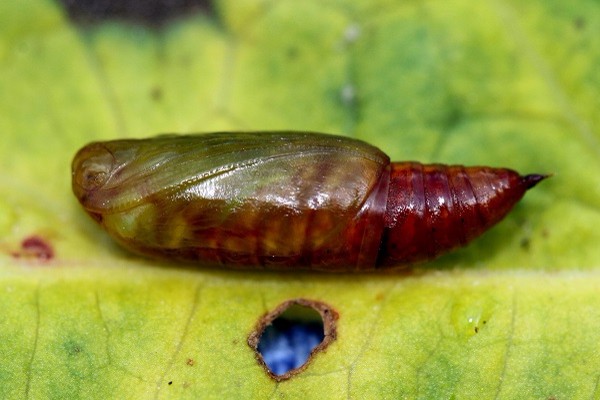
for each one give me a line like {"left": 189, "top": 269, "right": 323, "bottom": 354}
{"left": 248, "top": 299, "right": 338, "bottom": 381}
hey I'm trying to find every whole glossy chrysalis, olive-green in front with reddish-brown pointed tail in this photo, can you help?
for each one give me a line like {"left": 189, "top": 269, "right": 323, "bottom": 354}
{"left": 72, "top": 132, "right": 546, "bottom": 272}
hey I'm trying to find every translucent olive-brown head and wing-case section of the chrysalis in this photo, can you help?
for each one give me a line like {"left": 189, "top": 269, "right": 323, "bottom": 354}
{"left": 72, "top": 132, "right": 389, "bottom": 270}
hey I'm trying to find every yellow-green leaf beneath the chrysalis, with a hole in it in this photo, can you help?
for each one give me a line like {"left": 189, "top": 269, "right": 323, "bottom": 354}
{"left": 0, "top": 0, "right": 600, "bottom": 398}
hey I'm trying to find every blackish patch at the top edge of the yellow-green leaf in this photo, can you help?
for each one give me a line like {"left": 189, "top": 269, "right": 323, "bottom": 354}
{"left": 60, "top": 0, "right": 214, "bottom": 25}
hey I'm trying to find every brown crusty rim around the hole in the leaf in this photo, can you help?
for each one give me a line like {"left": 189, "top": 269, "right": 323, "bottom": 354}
{"left": 248, "top": 298, "right": 339, "bottom": 382}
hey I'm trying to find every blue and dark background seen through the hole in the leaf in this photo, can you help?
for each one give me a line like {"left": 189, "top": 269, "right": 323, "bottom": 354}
{"left": 258, "top": 318, "right": 324, "bottom": 375}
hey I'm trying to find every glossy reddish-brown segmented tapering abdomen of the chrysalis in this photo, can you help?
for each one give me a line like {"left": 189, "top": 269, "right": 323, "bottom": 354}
{"left": 378, "top": 162, "right": 544, "bottom": 266}
